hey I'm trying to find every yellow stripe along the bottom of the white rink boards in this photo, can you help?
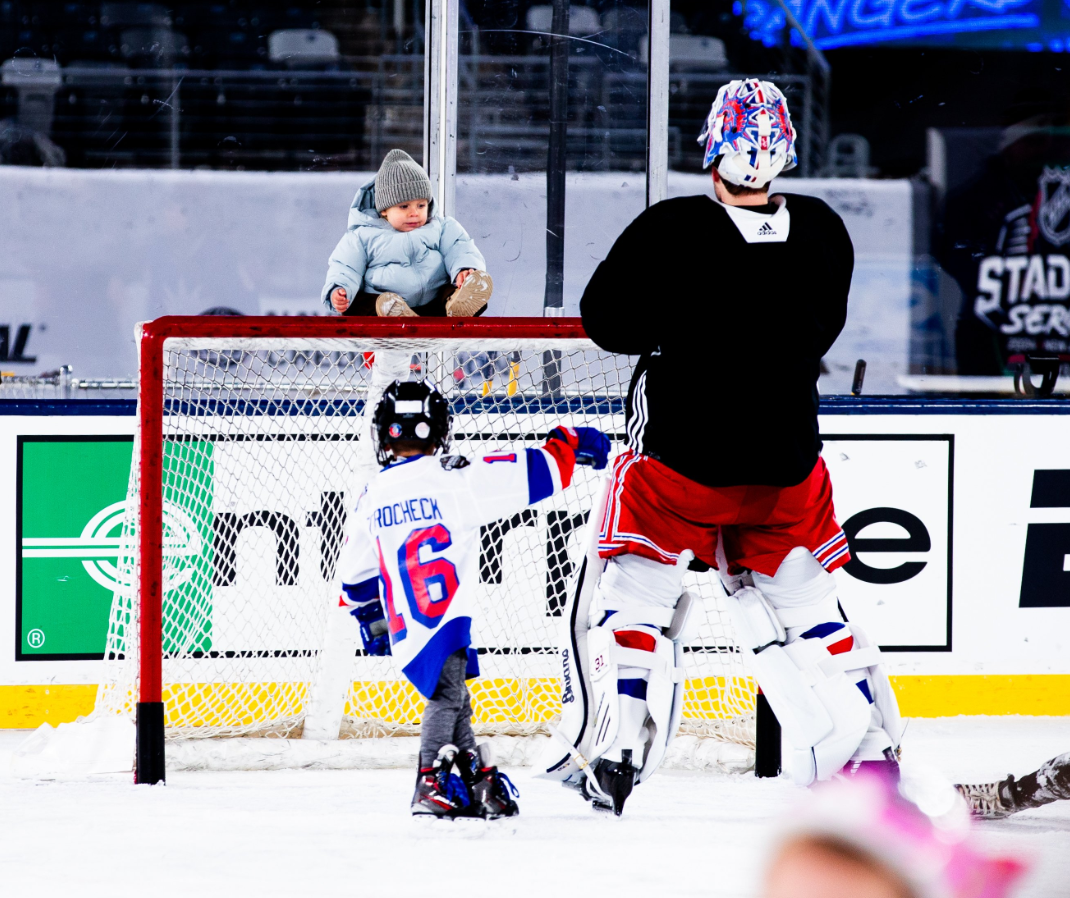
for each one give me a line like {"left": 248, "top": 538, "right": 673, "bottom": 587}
{"left": 6, "top": 673, "right": 1070, "bottom": 729}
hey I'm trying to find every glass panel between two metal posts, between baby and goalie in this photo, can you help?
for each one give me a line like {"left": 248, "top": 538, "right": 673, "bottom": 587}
{"left": 457, "top": 2, "right": 647, "bottom": 315}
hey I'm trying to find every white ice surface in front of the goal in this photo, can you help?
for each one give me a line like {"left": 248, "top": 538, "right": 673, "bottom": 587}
{"left": 6, "top": 717, "right": 1070, "bottom": 898}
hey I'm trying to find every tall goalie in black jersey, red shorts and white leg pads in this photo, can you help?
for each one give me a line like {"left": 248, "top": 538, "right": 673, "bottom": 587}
{"left": 541, "top": 80, "right": 902, "bottom": 813}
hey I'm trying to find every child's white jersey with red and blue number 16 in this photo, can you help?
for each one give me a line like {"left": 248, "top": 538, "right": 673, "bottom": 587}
{"left": 338, "top": 440, "right": 576, "bottom": 698}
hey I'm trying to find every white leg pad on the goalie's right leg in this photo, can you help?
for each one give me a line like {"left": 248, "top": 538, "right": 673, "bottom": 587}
{"left": 729, "top": 549, "right": 902, "bottom": 785}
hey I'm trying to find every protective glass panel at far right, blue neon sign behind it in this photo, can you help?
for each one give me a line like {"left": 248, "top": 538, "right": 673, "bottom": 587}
{"left": 670, "top": 0, "right": 1070, "bottom": 398}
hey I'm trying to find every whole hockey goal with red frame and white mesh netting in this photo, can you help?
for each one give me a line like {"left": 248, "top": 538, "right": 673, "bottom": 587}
{"left": 96, "top": 318, "right": 754, "bottom": 781}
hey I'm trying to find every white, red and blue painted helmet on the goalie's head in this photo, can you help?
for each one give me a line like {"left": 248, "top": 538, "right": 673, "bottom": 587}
{"left": 699, "top": 78, "right": 798, "bottom": 187}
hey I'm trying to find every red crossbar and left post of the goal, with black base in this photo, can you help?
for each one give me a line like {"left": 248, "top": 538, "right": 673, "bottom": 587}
{"left": 135, "top": 316, "right": 586, "bottom": 783}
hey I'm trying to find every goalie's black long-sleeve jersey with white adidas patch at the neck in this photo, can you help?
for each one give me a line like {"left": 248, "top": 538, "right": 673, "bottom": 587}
{"left": 580, "top": 194, "right": 854, "bottom": 486}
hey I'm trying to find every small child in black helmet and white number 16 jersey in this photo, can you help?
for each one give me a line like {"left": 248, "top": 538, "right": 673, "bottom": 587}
{"left": 339, "top": 381, "right": 610, "bottom": 818}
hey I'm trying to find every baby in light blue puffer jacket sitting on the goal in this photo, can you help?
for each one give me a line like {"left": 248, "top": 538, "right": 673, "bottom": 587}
{"left": 323, "top": 150, "right": 493, "bottom": 318}
